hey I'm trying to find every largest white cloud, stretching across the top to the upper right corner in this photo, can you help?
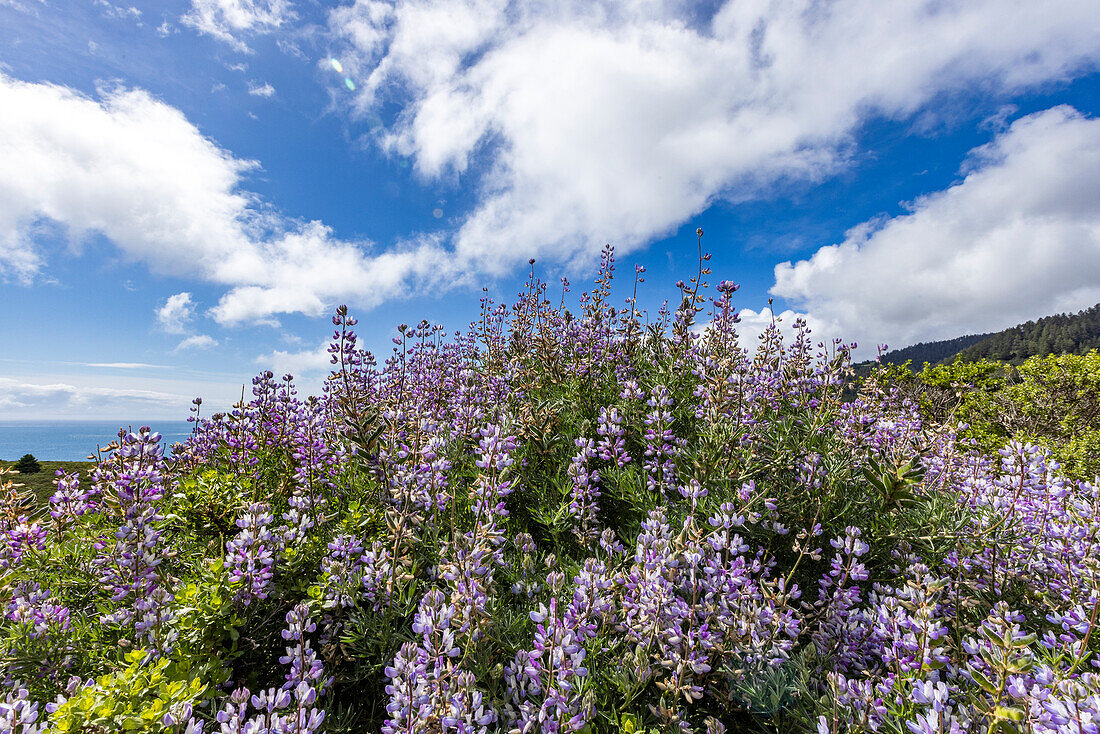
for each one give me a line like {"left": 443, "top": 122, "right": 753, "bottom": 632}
{"left": 329, "top": 0, "right": 1100, "bottom": 272}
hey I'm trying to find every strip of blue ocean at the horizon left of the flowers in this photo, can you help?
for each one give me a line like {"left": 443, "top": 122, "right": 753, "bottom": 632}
{"left": 0, "top": 420, "right": 191, "bottom": 461}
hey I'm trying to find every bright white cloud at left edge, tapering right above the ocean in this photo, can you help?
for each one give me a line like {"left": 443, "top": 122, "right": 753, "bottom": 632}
{"left": 0, "top": 74, "right": 453, "bottom": 325}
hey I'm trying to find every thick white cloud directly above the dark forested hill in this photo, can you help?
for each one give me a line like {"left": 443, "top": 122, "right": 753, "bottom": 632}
{"left": 771, "top": 107, "right": 1100, "bottom": 355}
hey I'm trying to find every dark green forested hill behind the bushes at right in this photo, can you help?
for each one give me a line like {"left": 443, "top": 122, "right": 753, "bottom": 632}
{"left": 882, "top": 304, "right": 1100, "bottom": 368}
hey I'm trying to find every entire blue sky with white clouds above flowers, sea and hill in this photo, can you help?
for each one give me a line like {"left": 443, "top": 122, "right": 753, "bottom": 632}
{"left": 0, "top": 0, "right": 1100, "bottom": 420}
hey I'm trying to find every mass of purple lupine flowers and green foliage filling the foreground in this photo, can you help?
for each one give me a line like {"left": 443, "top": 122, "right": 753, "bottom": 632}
{"left": 0, "top": 251, "right": 1100, "bottom": 734}
